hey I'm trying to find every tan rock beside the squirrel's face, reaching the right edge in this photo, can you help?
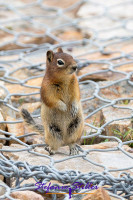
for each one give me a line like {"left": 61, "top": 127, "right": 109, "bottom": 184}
{"left": 78, "top": 58, "right": 132, "bottom": 81}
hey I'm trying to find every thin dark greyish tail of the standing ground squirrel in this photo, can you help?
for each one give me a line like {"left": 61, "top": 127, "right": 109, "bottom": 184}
{"left": 21, "top": 108, "right": 44, "bottom": 133}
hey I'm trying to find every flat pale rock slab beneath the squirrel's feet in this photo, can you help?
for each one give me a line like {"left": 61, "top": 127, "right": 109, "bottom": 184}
{"left": 3, "top": 142, "right": 133, "bottom": 179}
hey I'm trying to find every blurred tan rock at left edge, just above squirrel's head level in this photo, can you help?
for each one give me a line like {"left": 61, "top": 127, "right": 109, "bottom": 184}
{"left": 0, "top": 28, "right": 54, "bottom": 50}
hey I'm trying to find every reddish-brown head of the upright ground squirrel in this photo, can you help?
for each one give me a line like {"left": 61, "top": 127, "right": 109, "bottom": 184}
{"left": 46, "top": 48, "right": 77, "bottom": 76}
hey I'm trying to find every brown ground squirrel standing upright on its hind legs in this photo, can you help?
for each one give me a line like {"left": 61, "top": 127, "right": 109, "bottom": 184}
{"left": 21, "top": 48, "right": 84, "bottom": 155}
